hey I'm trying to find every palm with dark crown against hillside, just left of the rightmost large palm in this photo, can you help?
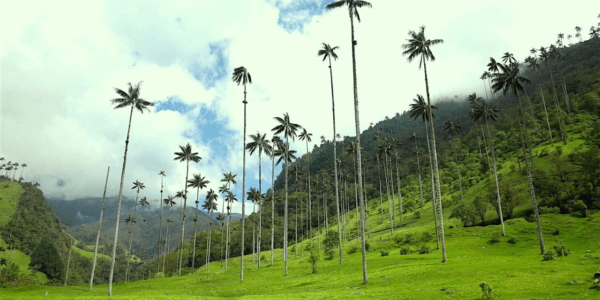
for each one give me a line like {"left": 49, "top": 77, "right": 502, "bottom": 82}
{"left": 468, "top": 93, "right": 506, "bottom": 236}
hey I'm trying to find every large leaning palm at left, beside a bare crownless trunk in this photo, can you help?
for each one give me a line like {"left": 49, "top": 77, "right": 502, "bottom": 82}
{"left": 108, "top": 82, "right": 154, "bottom": 296}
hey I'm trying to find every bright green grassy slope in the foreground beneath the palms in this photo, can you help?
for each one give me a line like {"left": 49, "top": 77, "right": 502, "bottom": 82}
{"left": 0, "top": 213, "right": 600, "bottom": 299}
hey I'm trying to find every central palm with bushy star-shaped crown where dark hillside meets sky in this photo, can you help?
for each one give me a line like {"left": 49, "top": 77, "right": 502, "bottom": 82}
{"left": 271, "top": 113, "right": 302, "bottom": 276}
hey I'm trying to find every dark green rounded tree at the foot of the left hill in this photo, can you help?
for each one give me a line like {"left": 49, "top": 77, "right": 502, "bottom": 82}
{"left": 29, "top": 237, "right": 65, "bottom": 280}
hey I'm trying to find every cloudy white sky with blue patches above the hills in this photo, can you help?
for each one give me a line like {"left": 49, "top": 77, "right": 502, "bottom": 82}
{"left": 0, "top": 0, "right": 600, "bottom": 216}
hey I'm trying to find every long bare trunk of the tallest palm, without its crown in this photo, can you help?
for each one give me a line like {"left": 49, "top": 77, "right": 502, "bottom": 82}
{"left": 349, "top": 10, "right": 369, "bottom": 284}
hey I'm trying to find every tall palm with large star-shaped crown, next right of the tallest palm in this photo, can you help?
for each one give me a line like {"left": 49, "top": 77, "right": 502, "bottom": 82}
{"left": 402, "top": 26, "right": 447, "bottom": 262}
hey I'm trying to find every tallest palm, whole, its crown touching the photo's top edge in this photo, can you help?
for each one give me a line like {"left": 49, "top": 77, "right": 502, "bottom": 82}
{"left": 325, "top": 0, "right": 372, "bottom": 284}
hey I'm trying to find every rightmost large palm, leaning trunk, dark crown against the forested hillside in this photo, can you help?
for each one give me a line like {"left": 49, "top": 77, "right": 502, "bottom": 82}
{"left": 492, "top": 64, "right": 546, "bottom": 254}
